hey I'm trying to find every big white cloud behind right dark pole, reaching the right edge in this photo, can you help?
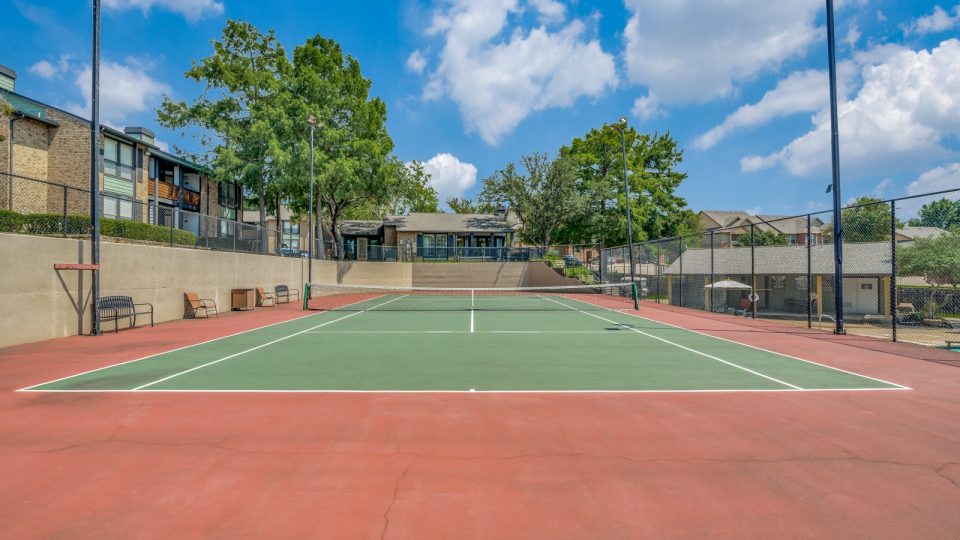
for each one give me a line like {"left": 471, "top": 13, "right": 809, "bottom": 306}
{"left": 741, "top": 39, "right": 960, "bottom": 176}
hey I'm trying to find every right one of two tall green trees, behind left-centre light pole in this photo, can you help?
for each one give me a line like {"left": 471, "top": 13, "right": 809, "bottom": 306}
{"left": 278, "top": 35, "right": 396, "bottom": 257}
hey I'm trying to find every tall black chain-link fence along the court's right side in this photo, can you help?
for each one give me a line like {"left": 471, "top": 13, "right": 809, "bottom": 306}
{"left": 600, "top": 189, "right": 960, "bottom": 350}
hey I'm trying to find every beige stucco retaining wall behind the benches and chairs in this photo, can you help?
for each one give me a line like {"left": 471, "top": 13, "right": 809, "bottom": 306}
{"left": 0, "top": 234, "right": 412, "bottom": 347}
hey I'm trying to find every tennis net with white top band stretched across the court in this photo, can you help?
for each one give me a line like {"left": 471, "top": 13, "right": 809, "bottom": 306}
{"left": 304, "top": 283, "right": 638, "bottom": 311}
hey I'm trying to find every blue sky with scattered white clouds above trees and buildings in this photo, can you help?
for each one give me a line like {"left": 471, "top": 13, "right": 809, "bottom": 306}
{"left": 0, "top": 0, "right": 960, "bottom": 214}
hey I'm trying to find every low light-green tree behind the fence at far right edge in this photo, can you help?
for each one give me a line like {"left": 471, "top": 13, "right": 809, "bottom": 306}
{"left": 897, "top": 232, "right": 960, "bottom": 316}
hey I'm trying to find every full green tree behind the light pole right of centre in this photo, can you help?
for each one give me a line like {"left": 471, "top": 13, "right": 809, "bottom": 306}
{"left": 559, "top": 126, "right": 700, "bottom": 245}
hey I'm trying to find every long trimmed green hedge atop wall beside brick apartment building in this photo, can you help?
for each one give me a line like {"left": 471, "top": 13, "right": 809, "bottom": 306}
{"left": 0, "top": 211, "right": 197, "bottom": 246}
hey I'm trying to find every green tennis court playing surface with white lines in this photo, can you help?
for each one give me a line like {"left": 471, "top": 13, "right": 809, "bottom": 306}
{"left": 24, "top": 294, "right": 904, "bottom": 392}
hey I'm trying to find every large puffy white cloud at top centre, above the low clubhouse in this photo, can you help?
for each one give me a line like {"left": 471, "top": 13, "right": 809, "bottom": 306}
{"left": 423, "top": 0, "right": 617, "bottom": 145}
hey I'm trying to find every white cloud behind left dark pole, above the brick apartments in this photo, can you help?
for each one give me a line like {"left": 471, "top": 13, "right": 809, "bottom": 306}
{"left": 67, "top": 59, "right": 170, "bottom": 124}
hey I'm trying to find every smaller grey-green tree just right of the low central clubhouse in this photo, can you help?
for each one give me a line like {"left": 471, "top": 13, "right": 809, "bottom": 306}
{"left": 481, "top": 153, "right": 586, "bottom": 249}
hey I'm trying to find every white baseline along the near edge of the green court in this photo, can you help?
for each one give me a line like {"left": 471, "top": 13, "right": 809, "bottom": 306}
{"left": 18, "top": 387, "right": 909, "bottom": 394}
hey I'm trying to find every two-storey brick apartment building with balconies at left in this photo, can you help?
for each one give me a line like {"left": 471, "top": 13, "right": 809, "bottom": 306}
{"left": 0, "top": 62, "right": 241, "bottom": 236}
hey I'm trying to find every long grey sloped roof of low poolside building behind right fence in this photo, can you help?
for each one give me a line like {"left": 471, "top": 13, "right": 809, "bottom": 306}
{"left": 663, "top": 242, "right": 892, "bottom": 276}
